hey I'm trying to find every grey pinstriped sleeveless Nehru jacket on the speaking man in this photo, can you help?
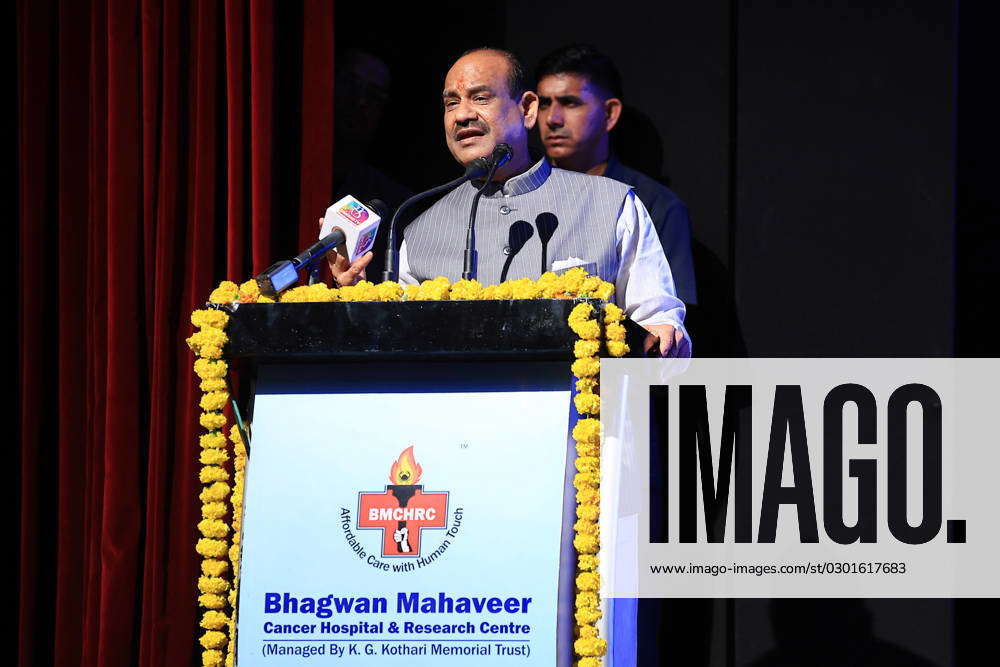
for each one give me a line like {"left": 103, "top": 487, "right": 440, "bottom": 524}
{"left": 404, "top": 158, "right": 631, "bottom": 285}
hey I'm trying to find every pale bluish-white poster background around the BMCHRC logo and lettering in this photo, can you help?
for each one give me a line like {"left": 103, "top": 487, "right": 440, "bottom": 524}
{"left": 238, "top": 390, "right": 569, "bottom": 667}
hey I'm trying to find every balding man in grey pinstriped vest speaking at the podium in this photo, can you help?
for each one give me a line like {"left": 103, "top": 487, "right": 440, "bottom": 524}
{"left": 330, "top": 48, "right": 691, "bottom": 357}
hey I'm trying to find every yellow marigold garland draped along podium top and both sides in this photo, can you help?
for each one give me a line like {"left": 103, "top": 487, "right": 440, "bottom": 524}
{"left": 187, "top": 268, "right": 628, "bottom": 667}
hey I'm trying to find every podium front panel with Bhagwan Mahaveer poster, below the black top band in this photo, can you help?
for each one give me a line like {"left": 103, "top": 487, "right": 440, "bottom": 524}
{"left": 238, "top": 361, "right": 572, "bottom": 666}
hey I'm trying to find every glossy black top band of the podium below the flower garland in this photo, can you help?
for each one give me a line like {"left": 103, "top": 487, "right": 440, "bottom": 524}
{"left": 226, "top": 299, "right": 648, "bottom": 363}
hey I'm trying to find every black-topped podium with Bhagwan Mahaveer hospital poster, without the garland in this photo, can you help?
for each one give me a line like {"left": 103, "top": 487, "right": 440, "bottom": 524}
{"left": 227, "top": 299, "right": 641, "bottom": 666}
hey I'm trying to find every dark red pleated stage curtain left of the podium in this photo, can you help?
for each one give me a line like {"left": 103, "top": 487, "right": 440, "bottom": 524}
{"left": 15, "top": 0, "right": 333, "bottom": 666}
